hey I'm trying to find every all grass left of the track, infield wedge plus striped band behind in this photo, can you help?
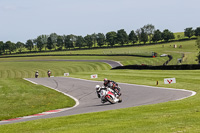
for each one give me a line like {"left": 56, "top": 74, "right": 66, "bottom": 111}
{"left": 0, "top": 60, "right": 111, "bottom": 120}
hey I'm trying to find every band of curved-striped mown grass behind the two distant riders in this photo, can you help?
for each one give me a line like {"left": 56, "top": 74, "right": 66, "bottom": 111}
{"left": 0, "top": 61, "right": 111, "bottom": 78}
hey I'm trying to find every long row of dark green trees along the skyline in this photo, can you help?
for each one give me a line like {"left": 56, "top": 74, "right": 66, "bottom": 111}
{"left": 0, "top": 24, "right": 200, "bottom": 54}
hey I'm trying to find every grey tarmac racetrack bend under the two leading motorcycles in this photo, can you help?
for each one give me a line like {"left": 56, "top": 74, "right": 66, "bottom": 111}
{"left": 0, "top": 77, "right": 195, "bottom": 125}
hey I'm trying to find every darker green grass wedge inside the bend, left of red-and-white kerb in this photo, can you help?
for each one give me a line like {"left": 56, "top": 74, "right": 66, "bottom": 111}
{"left": 0, "top": 78, "right": 75, "bottom": 120}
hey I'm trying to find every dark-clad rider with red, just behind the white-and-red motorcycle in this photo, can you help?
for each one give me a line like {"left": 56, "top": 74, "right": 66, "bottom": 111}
{"left": 103, "top": 78, "right": 121, "bottom": 95}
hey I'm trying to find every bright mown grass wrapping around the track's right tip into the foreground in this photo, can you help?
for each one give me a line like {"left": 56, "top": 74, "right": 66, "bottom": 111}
{"left": 0, "top": 70, "right": 200, "bottom": 133}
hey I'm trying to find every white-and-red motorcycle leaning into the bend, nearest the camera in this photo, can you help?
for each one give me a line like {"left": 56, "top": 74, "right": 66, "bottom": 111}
{"left": 100, "top": 88, "right": 122, "bottom": 104}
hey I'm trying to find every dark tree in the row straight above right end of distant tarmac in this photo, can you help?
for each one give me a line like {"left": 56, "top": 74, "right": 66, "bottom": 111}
{"left": 117, "top": 29, "right": 128, "bottom": 46}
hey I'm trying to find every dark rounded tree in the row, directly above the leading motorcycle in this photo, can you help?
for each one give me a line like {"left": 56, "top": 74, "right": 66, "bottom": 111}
{"left": 106, "top": 31, "right": 117, "bottom": 47}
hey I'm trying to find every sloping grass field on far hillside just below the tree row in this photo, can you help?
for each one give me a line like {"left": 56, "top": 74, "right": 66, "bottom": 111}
{"left": 1, "top": 40, "right": 198, "bottom": 65}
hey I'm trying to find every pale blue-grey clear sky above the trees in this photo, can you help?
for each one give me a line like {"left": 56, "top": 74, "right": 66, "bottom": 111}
{"left": 0, "top": 0, "right": 200, "bottom": 43}
